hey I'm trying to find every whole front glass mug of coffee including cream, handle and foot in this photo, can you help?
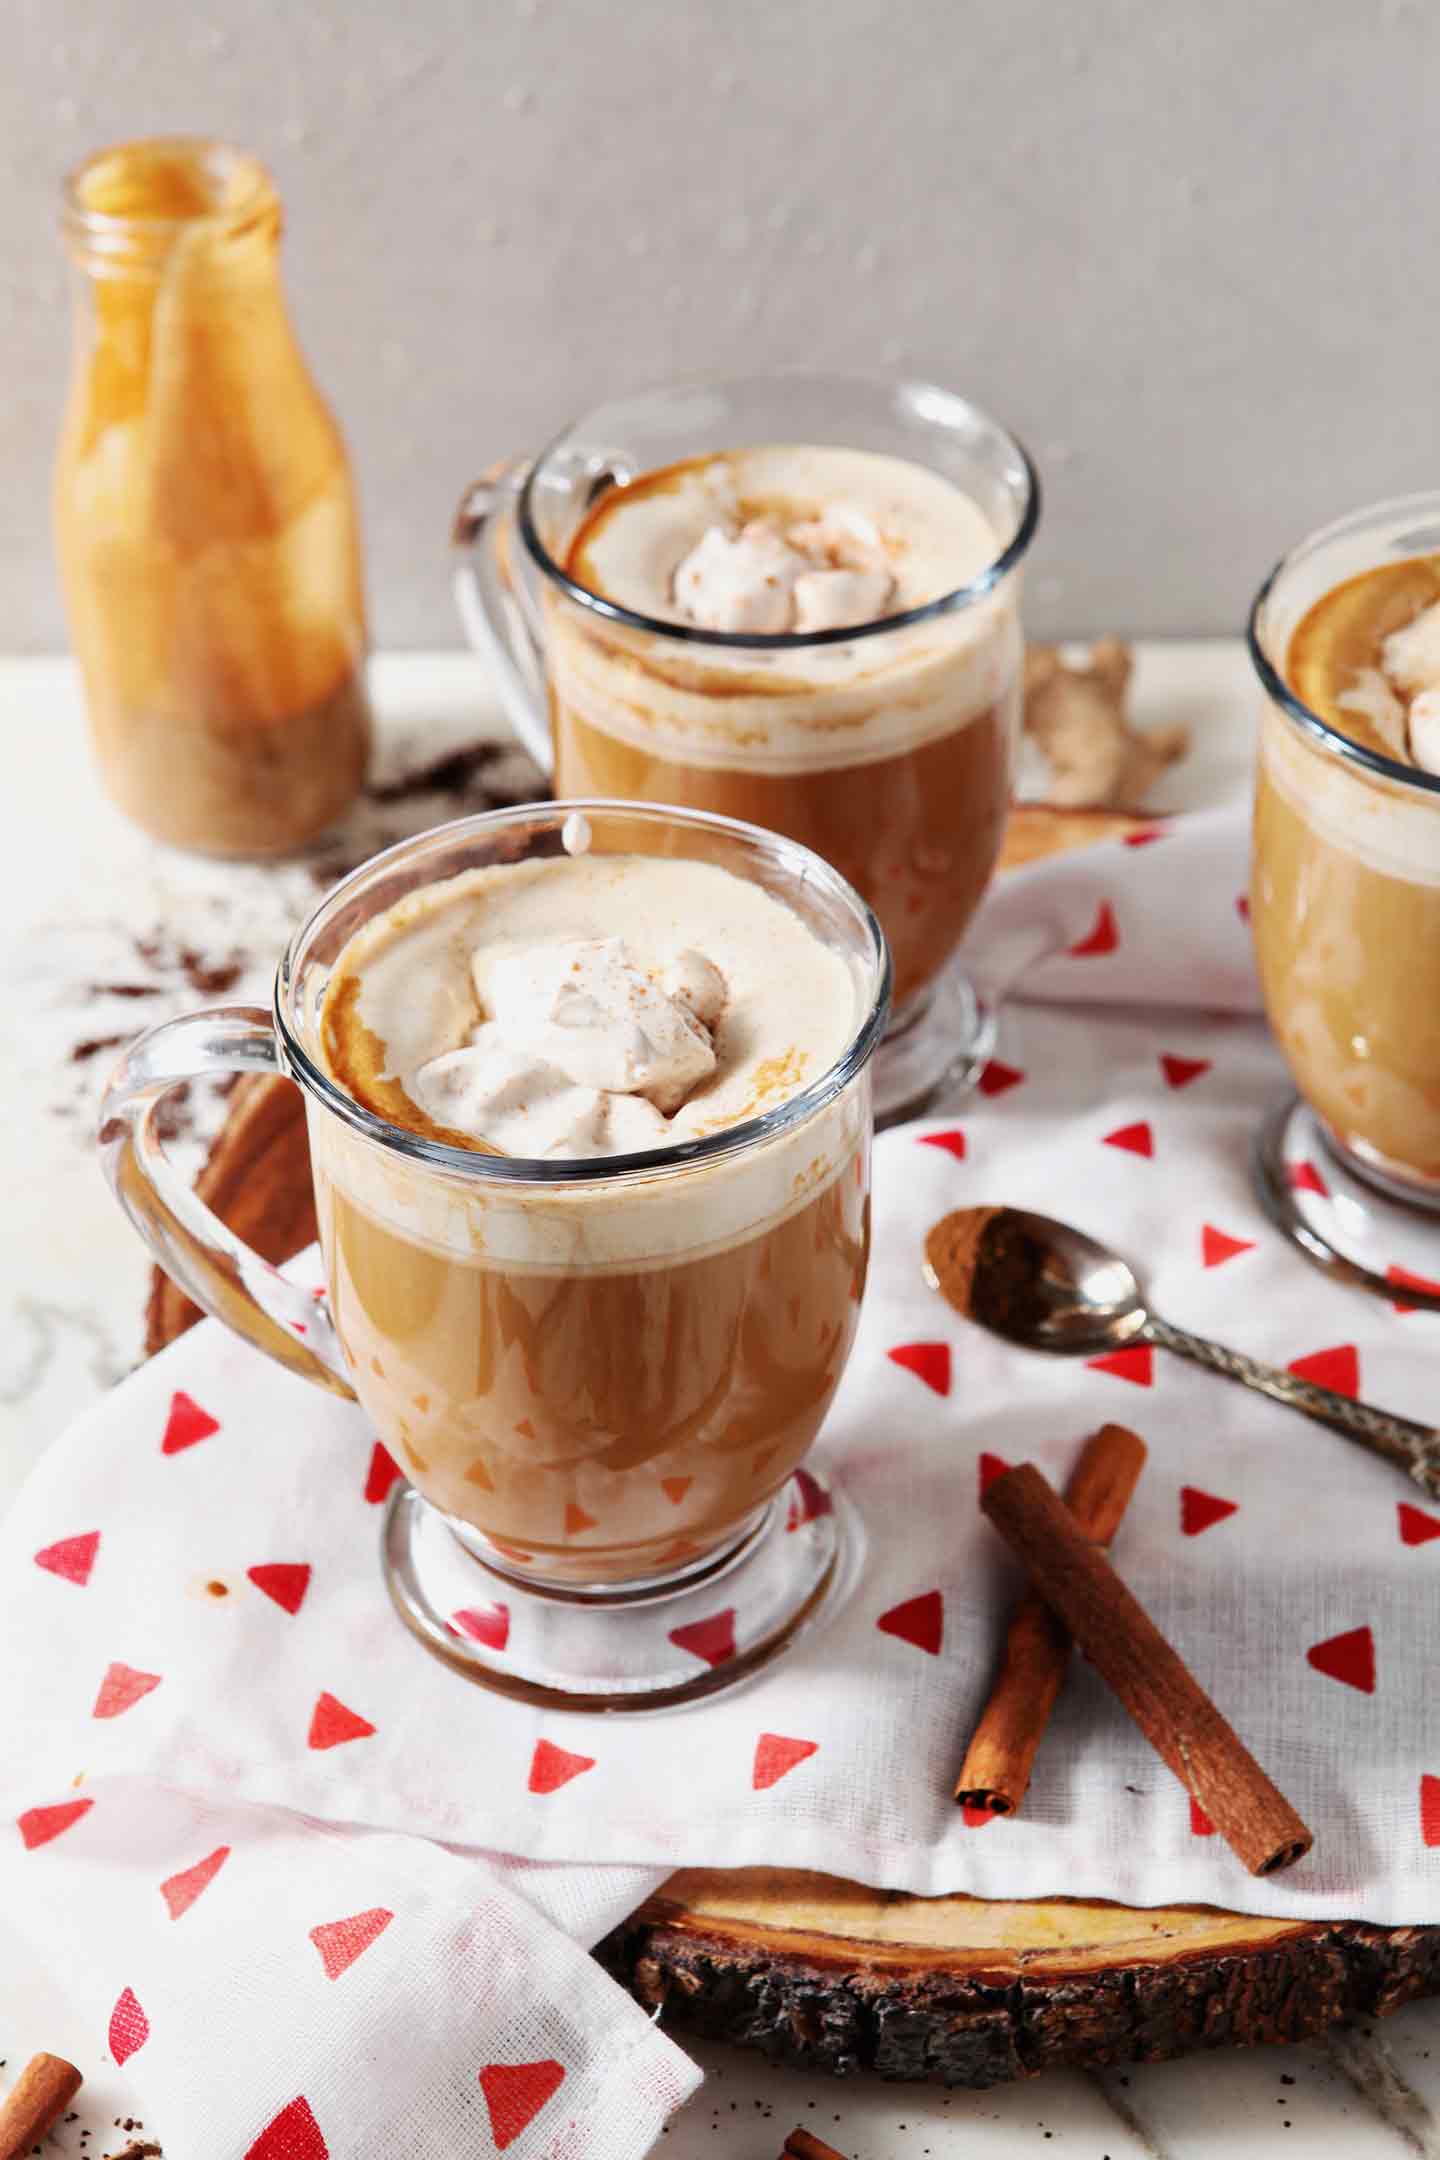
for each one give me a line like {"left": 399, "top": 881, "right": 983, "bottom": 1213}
{"left": 104, "top": 804, "right": 889, "bottom": 1706}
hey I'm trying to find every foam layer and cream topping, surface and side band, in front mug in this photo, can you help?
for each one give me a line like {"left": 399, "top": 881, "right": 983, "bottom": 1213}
{"left": 313, "top": 855, "right": 864, "bottom": 1268}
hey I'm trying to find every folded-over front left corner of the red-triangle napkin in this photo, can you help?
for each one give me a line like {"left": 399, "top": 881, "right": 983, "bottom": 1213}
{"left": 4, "top": 1771, "right": 699, "bottom": 2160}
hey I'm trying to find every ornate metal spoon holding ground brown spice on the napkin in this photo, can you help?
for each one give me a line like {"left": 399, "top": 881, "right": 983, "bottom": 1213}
{"left": 924, "top": 1207, "right": 1440, "bottom": 1499}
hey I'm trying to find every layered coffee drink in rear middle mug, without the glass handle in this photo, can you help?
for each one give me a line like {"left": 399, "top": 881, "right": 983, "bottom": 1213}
{"left": 546, "top": 443, "right": 1021, "bottom": 1015}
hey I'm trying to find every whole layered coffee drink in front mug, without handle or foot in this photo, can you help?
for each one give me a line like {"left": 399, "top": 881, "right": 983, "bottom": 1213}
{"left": 311, "top": 816, "right": 870, "bottom": 1588}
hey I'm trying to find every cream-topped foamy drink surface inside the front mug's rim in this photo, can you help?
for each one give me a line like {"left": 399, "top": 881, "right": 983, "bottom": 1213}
{"left": 324, "top": 851, "right": 859, "bottom": 1160}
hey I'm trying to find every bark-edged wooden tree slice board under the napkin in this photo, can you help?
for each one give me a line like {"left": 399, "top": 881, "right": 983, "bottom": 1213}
{"left": 147, "top": 810, "right": 1440, "bottom": 2087}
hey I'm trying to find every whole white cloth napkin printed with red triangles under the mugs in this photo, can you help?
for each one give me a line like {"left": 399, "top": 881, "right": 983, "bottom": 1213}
{"left": 11, "top": 816, "right": 1440, "bottom": 2160}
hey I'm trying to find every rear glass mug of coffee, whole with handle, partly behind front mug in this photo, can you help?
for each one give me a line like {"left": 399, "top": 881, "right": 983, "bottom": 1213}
{"left": 458, "top": 376, "right": 1038, "bottom": 1112}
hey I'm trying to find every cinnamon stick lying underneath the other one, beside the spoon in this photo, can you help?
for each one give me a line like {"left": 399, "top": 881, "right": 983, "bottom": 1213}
{"left": 954, "top": 1426, "right": 1144, "bottom": 1814}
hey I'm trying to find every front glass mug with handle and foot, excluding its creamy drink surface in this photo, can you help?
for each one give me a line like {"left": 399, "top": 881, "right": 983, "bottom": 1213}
{"left": 101, "top": 801, "right": 889, "bottom": 1709}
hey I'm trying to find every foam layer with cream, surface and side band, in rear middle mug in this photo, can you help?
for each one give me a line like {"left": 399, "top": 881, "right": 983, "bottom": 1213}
{"left": 551, "top": 445, "right": 1019, "bottom": 771}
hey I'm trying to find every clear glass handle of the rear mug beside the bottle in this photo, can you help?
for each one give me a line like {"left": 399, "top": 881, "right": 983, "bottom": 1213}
{"left": 451, "top": 458, "right": 555, "bottom": 780}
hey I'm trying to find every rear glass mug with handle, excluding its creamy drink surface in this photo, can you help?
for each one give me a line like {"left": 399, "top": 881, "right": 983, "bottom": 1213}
{"left": 453, "top": 374, "right": 1041, "bottom": 1117}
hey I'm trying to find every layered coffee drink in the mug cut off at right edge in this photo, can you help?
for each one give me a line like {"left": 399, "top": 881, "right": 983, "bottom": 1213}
{"left": 1252, "top": 540, "right": 1440, "bottom": 1197}
